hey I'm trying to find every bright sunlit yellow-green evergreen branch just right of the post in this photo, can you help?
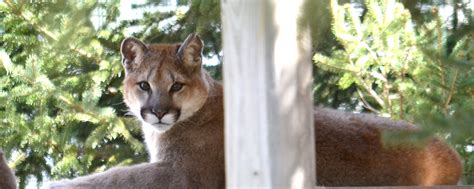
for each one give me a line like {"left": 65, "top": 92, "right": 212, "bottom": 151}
{"left": 314, "top": 1, "right": 423, "bottom": 118}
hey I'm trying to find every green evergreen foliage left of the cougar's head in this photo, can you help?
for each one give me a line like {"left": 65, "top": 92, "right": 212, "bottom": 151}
{"left": 0, "top": 1, "right": 145, "bottom": 188}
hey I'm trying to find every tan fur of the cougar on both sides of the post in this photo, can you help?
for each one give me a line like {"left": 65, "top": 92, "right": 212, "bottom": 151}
{"left": 52, "top": 34, "right": 462, "bottom": 188}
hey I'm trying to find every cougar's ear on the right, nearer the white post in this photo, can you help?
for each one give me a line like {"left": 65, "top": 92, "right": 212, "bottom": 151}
{"left": 177, "top": 33, "right": 204, "bottom": 71}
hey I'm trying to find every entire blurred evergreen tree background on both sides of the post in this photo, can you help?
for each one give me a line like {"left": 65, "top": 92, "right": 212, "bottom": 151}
{"left": 0, "top": 0, "right": 474, "bottom": 188}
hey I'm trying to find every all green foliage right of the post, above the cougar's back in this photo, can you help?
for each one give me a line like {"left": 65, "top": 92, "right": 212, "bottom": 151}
{"left": 313, "top": 0, "right": 474, "bottom": 183}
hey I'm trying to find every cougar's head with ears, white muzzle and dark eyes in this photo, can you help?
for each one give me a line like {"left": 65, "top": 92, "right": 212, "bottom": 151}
{"left": 121, "top": 34, "right": 209, "bottom": 132}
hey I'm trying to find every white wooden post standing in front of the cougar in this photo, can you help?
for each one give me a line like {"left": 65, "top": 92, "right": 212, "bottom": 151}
{"left": 221, "top": 0, "right": 316, "bottom": 188}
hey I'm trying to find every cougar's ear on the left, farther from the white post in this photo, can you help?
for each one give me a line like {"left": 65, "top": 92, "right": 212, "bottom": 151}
{"left": 120, "top": 37, "right": 148, "bottom": 72}
